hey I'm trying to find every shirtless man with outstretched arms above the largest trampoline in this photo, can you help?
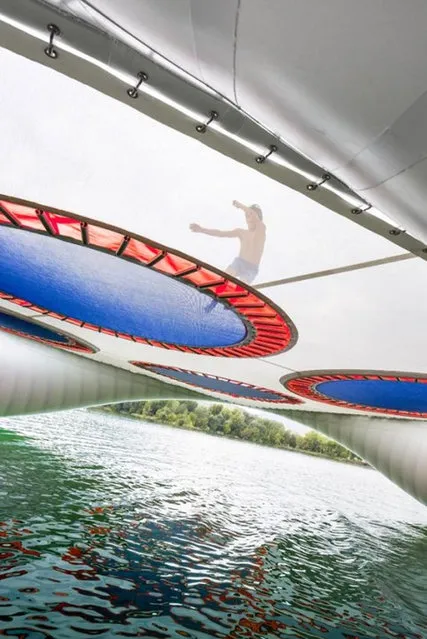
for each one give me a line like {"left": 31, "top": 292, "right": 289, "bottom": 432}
{"left": 190, "top": 200, "right": 266, "bottom": 284}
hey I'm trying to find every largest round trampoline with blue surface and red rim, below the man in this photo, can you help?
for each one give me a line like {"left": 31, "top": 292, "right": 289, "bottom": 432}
{"left": 0, "top": 200, "right": 296, "bottom": 357}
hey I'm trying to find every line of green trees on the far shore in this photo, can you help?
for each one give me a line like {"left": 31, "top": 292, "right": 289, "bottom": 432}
{"left": 105, "top": 399, "right": 362, "bottom": 462}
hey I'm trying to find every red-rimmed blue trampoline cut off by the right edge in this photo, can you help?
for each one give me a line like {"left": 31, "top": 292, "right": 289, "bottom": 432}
{"left": 281, "top": 371, "right": 427, "bottom": 418}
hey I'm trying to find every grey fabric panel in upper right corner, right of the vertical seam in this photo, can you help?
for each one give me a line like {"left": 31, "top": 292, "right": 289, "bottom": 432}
{"left": 236, "top": 0, "right": 427, "bottom": 171}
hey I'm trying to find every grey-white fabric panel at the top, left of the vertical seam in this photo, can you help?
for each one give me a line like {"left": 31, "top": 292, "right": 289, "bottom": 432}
{"left": 49, "top": 0, "right": 238, "bottom": 99}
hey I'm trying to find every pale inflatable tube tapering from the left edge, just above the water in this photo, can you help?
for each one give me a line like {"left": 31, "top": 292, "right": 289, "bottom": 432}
{"left": 0, "top": 333, "right": 209, "bottom": 417}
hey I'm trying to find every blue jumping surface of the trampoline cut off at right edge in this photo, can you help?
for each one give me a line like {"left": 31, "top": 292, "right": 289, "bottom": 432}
{"left": 316, "top": 380, "right": 427, "bottom": 413}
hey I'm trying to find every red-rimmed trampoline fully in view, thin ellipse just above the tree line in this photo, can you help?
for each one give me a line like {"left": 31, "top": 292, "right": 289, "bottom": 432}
{"left": 131, "top": 362, "right": 303, "bottom": 404}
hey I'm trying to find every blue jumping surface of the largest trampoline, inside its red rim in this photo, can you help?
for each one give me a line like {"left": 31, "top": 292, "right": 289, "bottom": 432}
{"left": 0, "top": 227, "right": 246, "bottom": 347}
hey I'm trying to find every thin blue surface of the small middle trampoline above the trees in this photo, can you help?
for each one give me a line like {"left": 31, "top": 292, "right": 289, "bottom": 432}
{"left": 144, "top": 366, "right": 283, "bottom": 401}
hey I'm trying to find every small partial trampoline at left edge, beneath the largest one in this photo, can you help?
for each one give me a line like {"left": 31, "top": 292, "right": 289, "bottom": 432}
{"left": 0, "top": 312, "right": 95, "bottom": 353}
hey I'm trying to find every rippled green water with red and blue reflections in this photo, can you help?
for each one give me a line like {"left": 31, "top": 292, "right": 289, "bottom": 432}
{"left": 0, "top": 411, "right": 427, "bottom": 639}
